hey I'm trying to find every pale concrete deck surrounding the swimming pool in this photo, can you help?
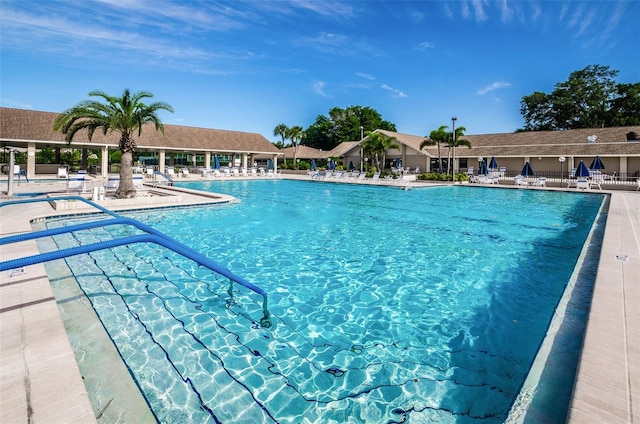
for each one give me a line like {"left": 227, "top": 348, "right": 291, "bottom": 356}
{"left": 0, "top": 176, "right": 640, "bottom": 423}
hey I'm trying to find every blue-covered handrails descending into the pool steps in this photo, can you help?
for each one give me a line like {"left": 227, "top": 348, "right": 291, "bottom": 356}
{"left": 0, "top": 196, "right": 271, "bottom": 328}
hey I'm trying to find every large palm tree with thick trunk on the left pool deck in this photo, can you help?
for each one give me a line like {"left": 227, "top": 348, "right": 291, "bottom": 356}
{"left": 53, "top": 89, "right": 173, "bottom": 199}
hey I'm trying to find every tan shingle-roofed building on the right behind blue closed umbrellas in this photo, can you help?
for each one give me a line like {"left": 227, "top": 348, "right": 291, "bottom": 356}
{"left": 344, "top": 126, "right": 640, "bottom": 178}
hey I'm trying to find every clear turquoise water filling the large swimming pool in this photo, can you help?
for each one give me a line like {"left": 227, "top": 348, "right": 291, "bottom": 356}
{"left": 48, "top": 181, "right": 604, "bottom": 423}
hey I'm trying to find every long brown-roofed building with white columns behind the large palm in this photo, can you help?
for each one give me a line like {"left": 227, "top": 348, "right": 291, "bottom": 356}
{"left": 0, "top": 108, "right": 280, "bottom": 176}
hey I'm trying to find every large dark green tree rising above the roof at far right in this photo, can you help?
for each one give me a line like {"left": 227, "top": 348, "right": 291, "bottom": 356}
{"left": 518, "top": 65, "right": 640, "bottom": 131}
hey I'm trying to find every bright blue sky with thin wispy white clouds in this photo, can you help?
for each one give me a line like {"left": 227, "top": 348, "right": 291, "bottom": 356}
{"left": 0, "top": 0, "right": 640, "bottom": 141}
